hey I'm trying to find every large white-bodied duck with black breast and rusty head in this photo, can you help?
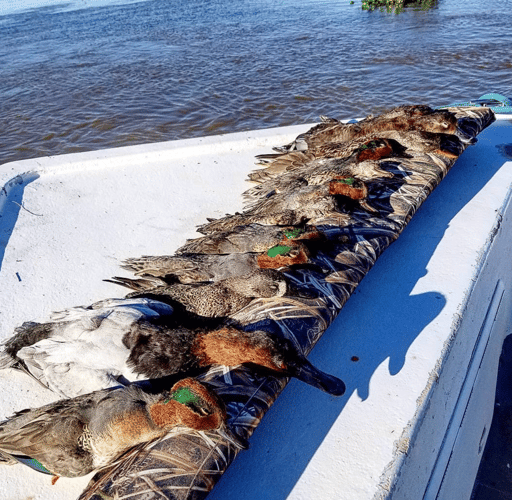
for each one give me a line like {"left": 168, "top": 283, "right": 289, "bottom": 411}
{"left": 1, "top": 299, "right": 344, "bottom": 397}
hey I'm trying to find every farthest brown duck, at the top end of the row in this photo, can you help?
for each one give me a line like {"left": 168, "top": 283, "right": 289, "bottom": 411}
{"left": 278, "top": 110, "right": 467, "bottom": 152}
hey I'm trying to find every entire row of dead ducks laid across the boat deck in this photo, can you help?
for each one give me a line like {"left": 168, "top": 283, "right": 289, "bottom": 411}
{"left": 0, "top": 105, "right": 494, "bottom": 494}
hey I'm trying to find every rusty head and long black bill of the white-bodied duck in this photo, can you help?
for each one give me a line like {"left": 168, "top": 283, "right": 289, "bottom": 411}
{"left": 195, "top": 328, "right": 345, "bottom": 396}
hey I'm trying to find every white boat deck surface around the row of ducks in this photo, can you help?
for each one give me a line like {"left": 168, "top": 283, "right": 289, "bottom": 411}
{"left": 0, "top": 117, "right": 512, "bottom": 500}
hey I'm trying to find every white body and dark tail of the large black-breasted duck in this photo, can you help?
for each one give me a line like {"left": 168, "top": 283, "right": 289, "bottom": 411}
{"left": 0, "top": 298, "right": 174, "bottom": 397}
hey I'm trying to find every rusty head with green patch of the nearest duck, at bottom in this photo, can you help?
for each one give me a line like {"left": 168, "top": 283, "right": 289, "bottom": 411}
{"left": 149, "top": 377, "right": 247, "bottom": 449}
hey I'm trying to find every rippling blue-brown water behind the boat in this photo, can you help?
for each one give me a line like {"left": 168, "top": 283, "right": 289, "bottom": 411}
{"left": 0, "top": 0, "right": 512, "bottom": 163}
